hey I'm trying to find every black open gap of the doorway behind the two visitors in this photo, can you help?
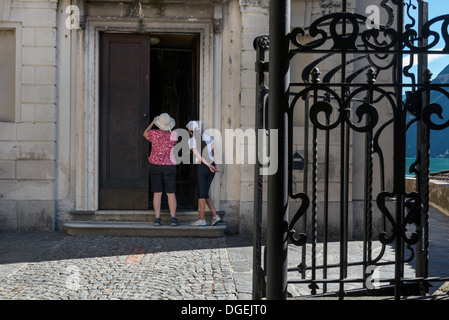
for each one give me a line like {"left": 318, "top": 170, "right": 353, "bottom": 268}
{"left": 149, "top": 34, "right": 199, "bottom": 210}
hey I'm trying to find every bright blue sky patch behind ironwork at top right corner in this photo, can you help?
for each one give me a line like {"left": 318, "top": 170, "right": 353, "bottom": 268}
{"left": 403, "top": 0, "right": 449, "bottom": 79}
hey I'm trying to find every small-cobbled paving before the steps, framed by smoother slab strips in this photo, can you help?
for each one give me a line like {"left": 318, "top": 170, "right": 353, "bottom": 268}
{"left": 0, "top": 237, "right": 237, "bottom": 300}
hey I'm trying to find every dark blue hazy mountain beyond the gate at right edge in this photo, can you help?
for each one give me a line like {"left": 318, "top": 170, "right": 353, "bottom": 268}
{"left": 406, "top": 65, "right": 449, "bottom": 158}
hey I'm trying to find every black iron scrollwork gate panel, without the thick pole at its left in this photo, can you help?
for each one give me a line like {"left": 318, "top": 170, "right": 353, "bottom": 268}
{"left": 256, "top": 0, "right": 449, "bottom": 296}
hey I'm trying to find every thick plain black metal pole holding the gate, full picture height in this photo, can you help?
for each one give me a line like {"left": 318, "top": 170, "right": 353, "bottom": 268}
{"left": 267, "top": 0, "right": 290, "bottom": 300}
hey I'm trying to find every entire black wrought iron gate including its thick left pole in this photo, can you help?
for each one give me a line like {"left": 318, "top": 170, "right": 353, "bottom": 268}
{"left": 253, "top": 0, "right": 449, "bottom": 299}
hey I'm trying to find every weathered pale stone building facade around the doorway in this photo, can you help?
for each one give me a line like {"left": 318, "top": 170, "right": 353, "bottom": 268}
{"left": 0, "top": 0, "right": 388, "bottom": 233}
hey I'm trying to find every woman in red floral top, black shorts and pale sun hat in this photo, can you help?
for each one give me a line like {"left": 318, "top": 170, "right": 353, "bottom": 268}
{"left": 143, "top": 113, "right": 178, "bottom": 226}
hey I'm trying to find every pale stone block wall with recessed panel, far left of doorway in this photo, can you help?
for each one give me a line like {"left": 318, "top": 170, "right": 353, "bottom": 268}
{"left": 0, "top": 0, "right": 57, "bottom": 231}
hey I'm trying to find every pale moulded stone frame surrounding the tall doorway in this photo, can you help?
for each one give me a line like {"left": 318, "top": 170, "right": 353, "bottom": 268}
{"left": 75, "top": 18, "right": 222, "bottom": 211}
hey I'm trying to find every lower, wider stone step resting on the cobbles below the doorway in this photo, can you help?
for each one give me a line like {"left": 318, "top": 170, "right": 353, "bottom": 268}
{"left": 64, "top": 219, "right": 226, "bottom": 238}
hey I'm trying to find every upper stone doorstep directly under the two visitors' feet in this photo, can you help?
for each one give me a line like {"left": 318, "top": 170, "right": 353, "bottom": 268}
{"left": 70, "top": 210, "right": 226, "bottom": 222}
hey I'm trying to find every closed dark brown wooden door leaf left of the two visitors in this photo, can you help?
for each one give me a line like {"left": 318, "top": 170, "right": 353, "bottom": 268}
{"left": 99, "top": 33, "right": 150, "bottom": 209}
